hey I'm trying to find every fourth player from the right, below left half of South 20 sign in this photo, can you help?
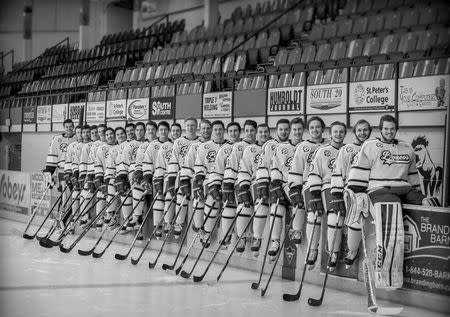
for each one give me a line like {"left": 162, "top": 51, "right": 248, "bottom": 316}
{"left": 288, "top": 116, "right": 327, "bottom": 244}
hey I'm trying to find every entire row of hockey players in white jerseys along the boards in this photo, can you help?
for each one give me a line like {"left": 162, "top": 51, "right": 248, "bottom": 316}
{"left": 40, "top": 115, "right": 437, "bottom": 287}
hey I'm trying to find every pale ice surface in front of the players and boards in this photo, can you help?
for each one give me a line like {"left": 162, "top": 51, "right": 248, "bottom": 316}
{"left": 0, "top": 219, "right": 444, "bottom": 317}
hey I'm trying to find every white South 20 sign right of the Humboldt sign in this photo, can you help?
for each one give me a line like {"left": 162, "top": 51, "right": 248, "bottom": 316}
{"left": 306, "top": 83, "right": 347, "bottom": 114}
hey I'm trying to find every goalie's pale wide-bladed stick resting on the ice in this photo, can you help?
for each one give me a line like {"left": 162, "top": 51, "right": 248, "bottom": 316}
{"left": 361, "top": 218, "right": 403, "bottom": 315}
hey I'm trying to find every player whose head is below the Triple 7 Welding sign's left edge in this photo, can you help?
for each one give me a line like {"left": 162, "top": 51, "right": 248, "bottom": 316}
{"left": 176, "top": 119, "right": 212, "bottom": 237}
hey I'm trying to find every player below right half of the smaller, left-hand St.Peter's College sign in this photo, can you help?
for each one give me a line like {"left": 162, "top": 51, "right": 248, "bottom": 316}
{"left": 103, "top": 125, "right": 126, "bottom": 229}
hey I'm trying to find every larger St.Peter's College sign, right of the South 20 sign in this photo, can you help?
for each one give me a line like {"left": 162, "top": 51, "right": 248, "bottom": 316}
{"left": 348, "top": 79, "right": 395, "bottom": 112}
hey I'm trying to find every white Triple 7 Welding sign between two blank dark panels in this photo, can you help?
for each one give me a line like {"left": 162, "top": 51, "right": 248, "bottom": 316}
{"left": 203, "top": 91, "right": 233, "bottom": 118}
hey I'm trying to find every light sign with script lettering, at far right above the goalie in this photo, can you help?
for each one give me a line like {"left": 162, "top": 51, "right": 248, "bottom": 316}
{"left": 398, "top": 75, "right": 450, "bottom": 111}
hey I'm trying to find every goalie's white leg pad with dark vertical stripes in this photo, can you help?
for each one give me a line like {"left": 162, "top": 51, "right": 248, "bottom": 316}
{"left": 373, "top": 201, "right": 404, "bottom": 289}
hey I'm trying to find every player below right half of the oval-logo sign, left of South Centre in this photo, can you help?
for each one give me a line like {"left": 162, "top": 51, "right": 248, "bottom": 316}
{"left": 116, "top": 122, "right": 145, "bottom": 234}
